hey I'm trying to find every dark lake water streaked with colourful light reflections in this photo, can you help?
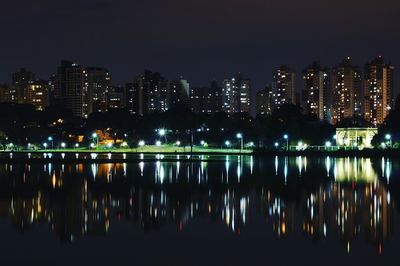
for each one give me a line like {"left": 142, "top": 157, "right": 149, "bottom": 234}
{"left": 0, "top": 156, "right": 400, "bottom": 266}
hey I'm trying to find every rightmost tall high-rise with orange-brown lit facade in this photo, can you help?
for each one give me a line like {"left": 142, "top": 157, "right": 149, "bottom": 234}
{"left": 364, "top": 56, "right": 395, "bottom": 126}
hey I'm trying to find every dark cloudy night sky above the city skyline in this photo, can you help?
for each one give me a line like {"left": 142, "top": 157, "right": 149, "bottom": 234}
{"left": 0, "top": 0, "right": 400, "bottom": 88}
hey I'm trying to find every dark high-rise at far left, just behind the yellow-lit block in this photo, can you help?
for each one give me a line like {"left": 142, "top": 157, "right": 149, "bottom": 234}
{"left": 10, "top": 68, "right": 35, "bottom": 103}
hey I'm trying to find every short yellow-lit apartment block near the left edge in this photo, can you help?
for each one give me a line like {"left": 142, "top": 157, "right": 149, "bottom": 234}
{"left": 26, "top": 80, "right": 50, "bottom": 111}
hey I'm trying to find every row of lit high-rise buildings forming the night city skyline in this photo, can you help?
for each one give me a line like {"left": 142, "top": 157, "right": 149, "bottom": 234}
{"left": 0, "top": 56, "right": 397, "bottom": 126}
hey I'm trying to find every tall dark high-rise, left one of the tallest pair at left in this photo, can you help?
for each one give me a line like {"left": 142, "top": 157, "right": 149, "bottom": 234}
{"left": 54, "top": 61, "right": 88, "bottom": 117}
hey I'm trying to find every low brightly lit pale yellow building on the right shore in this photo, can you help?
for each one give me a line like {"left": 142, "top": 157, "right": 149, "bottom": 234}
{"left": 336, "top": 128, "right": 378, "bottom": 148}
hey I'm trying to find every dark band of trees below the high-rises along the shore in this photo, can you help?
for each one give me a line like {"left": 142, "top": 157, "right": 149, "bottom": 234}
{"left": 0, "top": 101, "right": 400, "bottom": 147}
